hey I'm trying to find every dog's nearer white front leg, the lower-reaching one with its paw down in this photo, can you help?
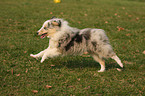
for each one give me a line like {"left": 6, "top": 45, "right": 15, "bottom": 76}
{"left": 41, "top": 48, "right": 61, "bottom": 63}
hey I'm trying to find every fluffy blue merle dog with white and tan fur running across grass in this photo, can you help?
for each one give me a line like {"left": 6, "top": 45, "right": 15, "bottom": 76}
{"left": 30, "top": 17, "right": 123, "bottom": 72}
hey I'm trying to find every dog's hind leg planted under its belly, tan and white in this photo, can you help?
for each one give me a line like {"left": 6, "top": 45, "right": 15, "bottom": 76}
{"left": 92, "top": 55, "right": 105, "bottom": 72}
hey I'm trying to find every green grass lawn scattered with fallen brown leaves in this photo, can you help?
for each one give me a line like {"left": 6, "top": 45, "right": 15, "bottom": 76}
{"left": 0, "top": 0, "right": 145, "bottom": 96}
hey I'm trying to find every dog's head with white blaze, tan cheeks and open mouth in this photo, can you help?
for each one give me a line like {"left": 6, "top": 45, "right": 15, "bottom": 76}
{"left": 37, "top": 17, "right": 62, "bottom": 38}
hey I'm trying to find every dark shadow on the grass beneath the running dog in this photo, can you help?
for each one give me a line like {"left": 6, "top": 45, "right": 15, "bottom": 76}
{"left": 46, "top": 56, "right": 118, "bottom": 70}
